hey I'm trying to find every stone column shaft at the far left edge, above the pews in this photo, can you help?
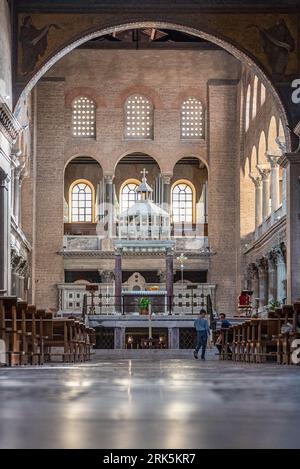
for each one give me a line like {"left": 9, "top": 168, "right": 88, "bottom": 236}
{"left": 0, "top": 168, "right": 10, "bottom": 295}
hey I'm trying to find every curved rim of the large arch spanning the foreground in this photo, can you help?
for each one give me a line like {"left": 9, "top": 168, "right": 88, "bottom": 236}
{"left": 16, "top": 19, "right": 294, "bottom": 150}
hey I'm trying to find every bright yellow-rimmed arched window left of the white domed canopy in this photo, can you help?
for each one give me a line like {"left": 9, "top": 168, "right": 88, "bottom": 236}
{"left": 69, "top": 179, "right": 95, "bottom": 223}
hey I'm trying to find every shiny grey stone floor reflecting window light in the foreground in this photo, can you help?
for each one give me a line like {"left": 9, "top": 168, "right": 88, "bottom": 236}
{"left": 0, "top": 358, "right": 300, "bottom": 449}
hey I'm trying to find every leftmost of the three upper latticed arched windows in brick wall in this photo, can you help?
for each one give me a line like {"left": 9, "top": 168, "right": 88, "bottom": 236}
{"left": 72, "top": 96, "right": 96, "bottom": 138}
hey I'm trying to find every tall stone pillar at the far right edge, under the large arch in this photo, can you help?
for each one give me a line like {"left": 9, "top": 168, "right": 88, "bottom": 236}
{"left": 280, "top": 152, "right": 300, "bottom": 304}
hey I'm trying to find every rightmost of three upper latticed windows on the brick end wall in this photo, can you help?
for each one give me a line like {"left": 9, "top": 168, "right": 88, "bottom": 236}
{"left": 180, "top": 98, "right": 204, "bottom": 140}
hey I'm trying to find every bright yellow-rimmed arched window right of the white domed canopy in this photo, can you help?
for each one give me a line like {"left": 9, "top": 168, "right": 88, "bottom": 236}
{"left": 172, "top": 179, "right": 196, "bottom": 223}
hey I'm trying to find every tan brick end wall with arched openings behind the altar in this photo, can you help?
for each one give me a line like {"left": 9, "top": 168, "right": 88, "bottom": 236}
{"left": 24, "top": 50, "right": 244, "bottom": 312}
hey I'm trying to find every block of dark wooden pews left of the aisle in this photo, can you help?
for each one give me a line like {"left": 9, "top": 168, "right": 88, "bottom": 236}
{"left": 0, "top": 297, "right": 96, "bottom": 366}
